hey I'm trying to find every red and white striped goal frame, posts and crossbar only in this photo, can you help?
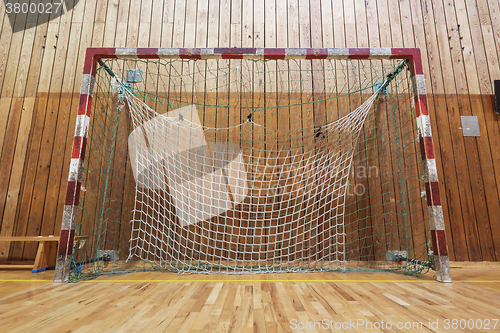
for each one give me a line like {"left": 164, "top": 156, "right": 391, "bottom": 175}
{"left": 54, "top": 47, "right": 451, "bottom": 282}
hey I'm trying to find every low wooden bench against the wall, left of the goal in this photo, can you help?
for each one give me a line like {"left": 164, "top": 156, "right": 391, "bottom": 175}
{"left": 0, "top": 236, "right": 59, "bottom": 273}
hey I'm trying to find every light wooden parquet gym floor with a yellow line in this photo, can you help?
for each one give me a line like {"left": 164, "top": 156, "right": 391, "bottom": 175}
{"left": 0, "top": 264, "right": 500, "bottom": 332}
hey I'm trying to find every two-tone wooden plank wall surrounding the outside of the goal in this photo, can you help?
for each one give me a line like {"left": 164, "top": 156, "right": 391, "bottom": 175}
{"left": 0, "top": 0, "right": 500, "bottom": 261}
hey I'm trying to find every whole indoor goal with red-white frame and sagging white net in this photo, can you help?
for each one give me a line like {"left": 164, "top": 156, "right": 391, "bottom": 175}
{"left": 55, "top": 48, "right": 451, "bottom": 281}
